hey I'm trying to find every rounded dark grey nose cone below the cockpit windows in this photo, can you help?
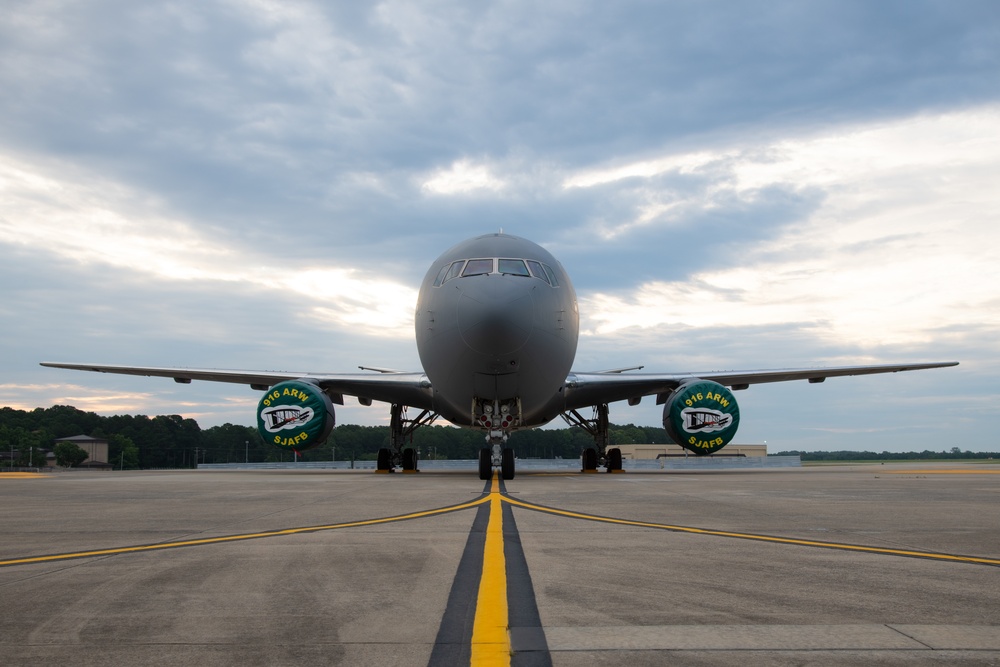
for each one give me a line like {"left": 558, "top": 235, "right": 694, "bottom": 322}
{"left": 458, "top": 276, "right": 535, "bottom": 355}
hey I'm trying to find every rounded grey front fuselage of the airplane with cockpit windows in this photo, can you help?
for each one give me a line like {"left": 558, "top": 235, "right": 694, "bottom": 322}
{"left": 415, "top": 234, "right": 580, "bottom": 430}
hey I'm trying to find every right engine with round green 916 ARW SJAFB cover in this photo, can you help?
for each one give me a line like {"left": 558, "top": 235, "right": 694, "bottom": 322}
{"left": 663, "top": 380, "right": 740, "bottom": 454}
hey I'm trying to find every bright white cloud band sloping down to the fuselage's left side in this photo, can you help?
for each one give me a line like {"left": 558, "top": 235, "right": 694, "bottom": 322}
{"left": 0, "top": 159, "right": 416, "bottom": 336}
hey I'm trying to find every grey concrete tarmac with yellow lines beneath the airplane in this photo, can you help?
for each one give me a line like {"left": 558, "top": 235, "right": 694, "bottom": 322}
{"left": 0, "top": 463, "right": 1000, "bottom": 665}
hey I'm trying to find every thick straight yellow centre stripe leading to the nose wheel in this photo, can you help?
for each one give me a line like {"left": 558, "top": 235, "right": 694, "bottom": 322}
{"left": 470, "top": 473, "right": 510, "bottom": 667}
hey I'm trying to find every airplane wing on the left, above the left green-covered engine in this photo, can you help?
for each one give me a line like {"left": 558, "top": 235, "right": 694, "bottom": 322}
{"left": 42, "top": 361, "right": 433, "bottom": 409}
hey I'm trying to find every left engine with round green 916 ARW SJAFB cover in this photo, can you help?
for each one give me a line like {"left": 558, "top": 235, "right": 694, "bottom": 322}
{"left": 257, "top": 380, "right": 336, "bottom": 452}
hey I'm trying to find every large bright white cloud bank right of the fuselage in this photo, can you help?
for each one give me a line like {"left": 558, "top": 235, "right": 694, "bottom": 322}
{"left": 567, "top": 106, "right": 1000, "bottom": 346}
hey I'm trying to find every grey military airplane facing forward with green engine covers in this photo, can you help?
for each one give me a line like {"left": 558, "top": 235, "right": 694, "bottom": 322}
{"left": 41, "top": 231, "right": 958, "bottom": 480}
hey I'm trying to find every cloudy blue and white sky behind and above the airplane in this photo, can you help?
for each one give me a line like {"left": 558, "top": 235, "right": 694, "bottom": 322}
{"left": 0, "top": 0, "right": 1000, "bottom": 451}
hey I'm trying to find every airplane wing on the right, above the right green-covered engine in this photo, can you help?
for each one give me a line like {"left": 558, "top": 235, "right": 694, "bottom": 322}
{"left": 566, "top": 361, "right": 958, "bottom": 410}
